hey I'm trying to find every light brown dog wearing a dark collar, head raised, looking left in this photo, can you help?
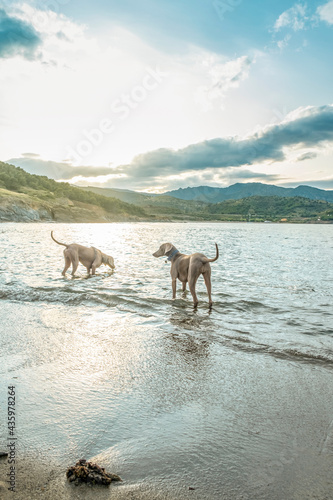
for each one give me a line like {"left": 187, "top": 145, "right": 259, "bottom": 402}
{"left": 153, "top": 243, "right": 219, "bottom": 307}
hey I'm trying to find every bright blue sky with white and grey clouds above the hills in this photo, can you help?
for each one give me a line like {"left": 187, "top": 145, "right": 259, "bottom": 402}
{"left": 0, "top": 0, "right": 333, "bottom": 193}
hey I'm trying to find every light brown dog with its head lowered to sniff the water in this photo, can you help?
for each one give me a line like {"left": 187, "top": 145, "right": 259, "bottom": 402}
{"left": 51, "top": 231, "right": 115, "bottom": 276}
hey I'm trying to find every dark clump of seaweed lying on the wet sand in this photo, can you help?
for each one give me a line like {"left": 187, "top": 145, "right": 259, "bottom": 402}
{"left": 66, "top": 459, "right": 121, "bottom": 486}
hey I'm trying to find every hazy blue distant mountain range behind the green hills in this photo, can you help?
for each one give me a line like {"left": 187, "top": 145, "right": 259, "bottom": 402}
{"left": 164, "top": 182, "right": 333, "bottom": 203}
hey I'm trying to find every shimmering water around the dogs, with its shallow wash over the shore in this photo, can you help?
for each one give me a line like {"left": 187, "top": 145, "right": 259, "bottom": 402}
{"left": 0, "top": 223, "right": 333, "bottom": 500}
